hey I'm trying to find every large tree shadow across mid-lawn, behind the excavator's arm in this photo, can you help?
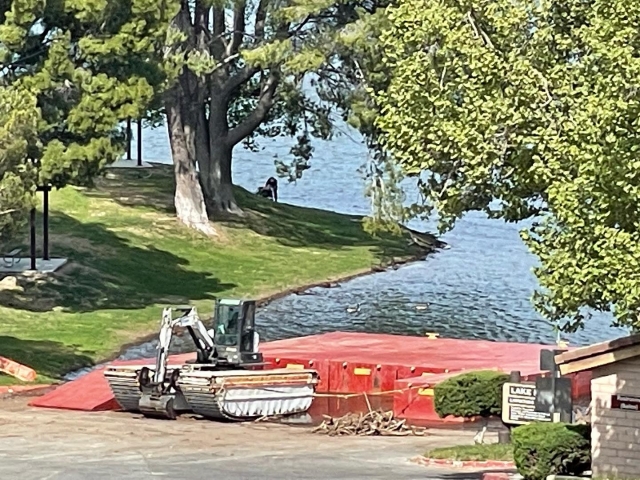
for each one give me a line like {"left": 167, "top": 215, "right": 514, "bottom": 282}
{"left": 0, "top": 212, "right": 235, "bottom": 312}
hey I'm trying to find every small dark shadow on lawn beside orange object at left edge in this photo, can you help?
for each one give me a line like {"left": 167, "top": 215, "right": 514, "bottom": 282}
{"left": 0, "top": 335, "right": 93, "bottom": 378}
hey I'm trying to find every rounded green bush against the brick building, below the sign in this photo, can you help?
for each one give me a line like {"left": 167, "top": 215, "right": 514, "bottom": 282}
{"left": 511, "top": 423, "right": 591, "bottom": 480}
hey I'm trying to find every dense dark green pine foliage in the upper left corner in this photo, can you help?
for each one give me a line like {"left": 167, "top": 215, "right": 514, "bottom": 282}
{"left": 0, "top": 0, "right": 167, "bottom": 234}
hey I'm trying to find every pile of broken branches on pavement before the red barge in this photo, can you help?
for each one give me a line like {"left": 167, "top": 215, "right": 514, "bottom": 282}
{"left": 312, "top": 410, "right": 425, "bottom": 437}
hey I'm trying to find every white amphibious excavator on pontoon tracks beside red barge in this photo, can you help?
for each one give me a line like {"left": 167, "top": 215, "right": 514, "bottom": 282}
{"left": 104, "top": 299, "right": 318, "bottom": 421}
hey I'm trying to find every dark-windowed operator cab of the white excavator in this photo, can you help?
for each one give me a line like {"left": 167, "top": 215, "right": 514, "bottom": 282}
{"left": 212, "top": 299, "right": 263, "bottom": 367}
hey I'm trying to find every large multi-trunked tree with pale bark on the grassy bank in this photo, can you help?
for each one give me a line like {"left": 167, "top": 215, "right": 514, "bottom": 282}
{"left": 158, "top": 0, "right": 384, "bottom": 231}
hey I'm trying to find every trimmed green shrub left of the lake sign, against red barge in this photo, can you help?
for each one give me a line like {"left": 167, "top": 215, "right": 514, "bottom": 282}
{"left": 434, "top": 370, "right": 509, "bottom": 417}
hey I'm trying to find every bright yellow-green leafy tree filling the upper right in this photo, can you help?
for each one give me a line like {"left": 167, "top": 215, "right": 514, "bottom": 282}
{"left": 371, "top": 0, "right": 640, "bottom": 330}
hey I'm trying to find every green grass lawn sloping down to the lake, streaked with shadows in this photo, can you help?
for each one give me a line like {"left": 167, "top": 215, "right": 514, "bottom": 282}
{"left": 0, "top": 167, "right": 416, "bottom": 384}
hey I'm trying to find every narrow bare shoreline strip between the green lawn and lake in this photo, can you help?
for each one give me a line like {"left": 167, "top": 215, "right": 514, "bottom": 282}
{"left": 86, "top": 251, "right": 436, "bottom": 376}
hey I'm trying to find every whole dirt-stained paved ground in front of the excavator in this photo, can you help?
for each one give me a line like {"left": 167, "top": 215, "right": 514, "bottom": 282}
{"left": 0, "top": 400, "right": 510, "bottom": 480}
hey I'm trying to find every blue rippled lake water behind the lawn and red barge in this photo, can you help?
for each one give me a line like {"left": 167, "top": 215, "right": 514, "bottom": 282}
{"left": 127, "top": 123, "right": 626, "bottom": 348}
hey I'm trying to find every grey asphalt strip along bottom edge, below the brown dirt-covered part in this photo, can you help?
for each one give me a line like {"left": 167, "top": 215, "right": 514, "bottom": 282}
{"left": 0, "top": 446, "right": 498, "bottom": 480}
